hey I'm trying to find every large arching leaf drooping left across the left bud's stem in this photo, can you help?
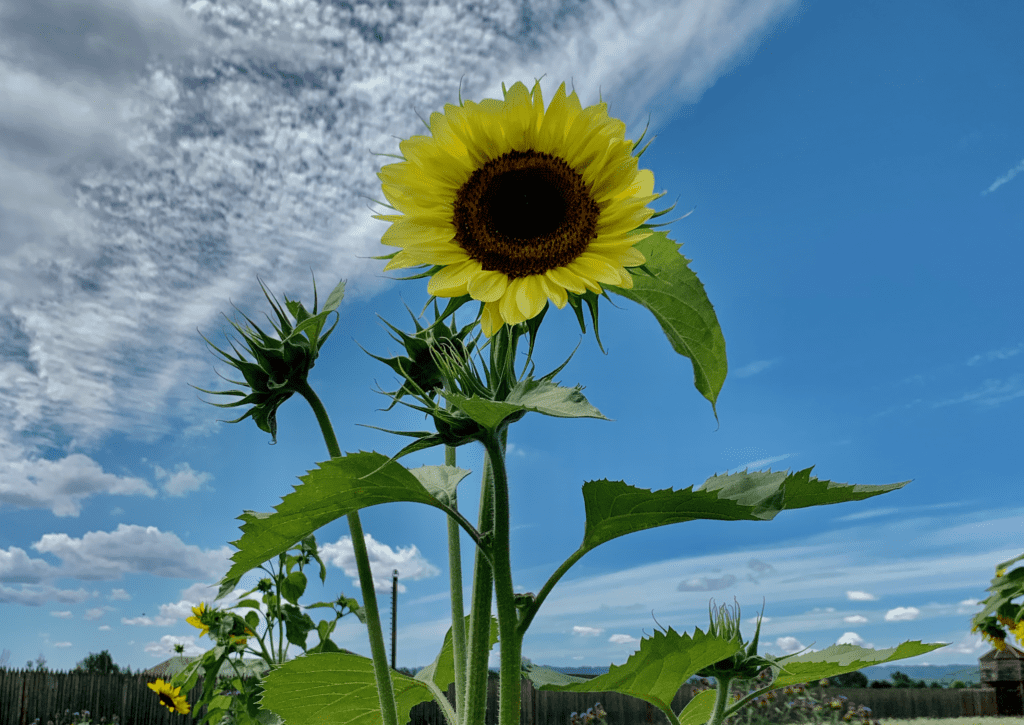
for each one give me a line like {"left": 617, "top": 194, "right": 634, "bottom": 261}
{"left": 218, "top": 452, "right": 479, "bottom": 596}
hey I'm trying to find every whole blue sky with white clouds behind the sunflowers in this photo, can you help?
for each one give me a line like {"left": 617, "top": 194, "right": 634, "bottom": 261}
{"left": 0, "top": 0, "right": 1024, "bottom": 670}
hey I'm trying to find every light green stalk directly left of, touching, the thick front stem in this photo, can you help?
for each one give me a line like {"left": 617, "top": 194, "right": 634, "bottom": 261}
{"left": 462, "top": 446, "right": 495, "bottom": 725}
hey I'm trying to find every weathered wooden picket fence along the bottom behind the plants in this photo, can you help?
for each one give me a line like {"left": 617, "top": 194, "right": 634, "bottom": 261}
{"left": 0, "top": 670, "right": 996, "bottom": 725}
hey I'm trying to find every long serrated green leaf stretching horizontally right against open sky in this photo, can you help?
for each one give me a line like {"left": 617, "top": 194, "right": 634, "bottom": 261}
{"left": 580, "top": 467, "right": 909, "bottom": 551}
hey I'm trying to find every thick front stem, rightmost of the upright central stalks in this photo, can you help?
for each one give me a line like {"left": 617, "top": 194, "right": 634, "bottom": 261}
{"left": 483, "top": 428, "right": 522, "bottom": 725}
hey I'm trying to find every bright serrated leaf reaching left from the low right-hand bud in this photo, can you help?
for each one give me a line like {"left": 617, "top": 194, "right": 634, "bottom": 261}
{"left": 526, "top": 627, "right": 742, "bottom": 721}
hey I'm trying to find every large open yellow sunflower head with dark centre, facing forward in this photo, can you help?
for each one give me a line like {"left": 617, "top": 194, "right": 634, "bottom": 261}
{"left": 374, "top": 77, "right": 663, "bottom": 337}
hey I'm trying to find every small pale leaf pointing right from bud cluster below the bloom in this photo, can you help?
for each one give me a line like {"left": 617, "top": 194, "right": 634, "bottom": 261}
{"left": 441, "top": 378, "right": 608, "bottom": 430}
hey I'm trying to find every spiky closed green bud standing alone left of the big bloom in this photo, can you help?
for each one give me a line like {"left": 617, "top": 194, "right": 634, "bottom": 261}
{"left": 191, "top": 272, "right": 345, "bottom": 443}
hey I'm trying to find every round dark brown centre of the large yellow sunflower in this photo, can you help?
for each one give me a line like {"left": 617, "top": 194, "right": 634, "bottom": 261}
{"left": 454, "top": 151, "right": 600, "bottom": 280}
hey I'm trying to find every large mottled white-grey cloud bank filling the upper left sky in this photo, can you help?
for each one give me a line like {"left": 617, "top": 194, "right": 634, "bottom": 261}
{"left": 0, "top": 0, "right": 799, "bottom": 516}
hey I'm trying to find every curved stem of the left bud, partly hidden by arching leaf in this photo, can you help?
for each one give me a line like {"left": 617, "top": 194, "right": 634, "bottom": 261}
{"left": 297, "top": 380, "right": 398, "bottom": 725}
